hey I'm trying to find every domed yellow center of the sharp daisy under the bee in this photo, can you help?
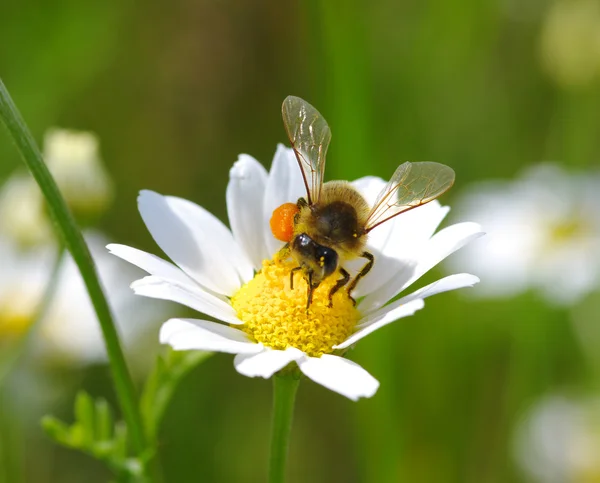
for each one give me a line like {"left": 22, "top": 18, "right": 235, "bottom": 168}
{"left": 231, "top": 260, "right": 360, "bottom": 357}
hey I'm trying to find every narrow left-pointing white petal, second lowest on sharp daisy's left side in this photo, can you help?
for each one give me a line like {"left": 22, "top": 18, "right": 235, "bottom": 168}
{"left": 131, "top": 276, "right": 242, "bottom": 324}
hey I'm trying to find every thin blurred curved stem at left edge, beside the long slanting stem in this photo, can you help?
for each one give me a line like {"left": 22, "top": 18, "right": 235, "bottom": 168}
{"left": 0, "top": 246, "right": 65, "bottom": 393}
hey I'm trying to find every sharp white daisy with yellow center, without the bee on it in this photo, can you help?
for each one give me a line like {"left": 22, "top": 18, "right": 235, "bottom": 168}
{"left": 108, "top": 146, "right": 482, "bottom": 400}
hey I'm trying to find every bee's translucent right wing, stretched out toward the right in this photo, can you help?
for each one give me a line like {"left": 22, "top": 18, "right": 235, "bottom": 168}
{"left": 365, "top": 162, "right": 454, "bottom": 232}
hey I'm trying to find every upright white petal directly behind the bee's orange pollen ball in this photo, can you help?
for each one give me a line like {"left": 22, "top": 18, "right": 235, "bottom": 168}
{"left": 263, "top": 144, "right": 306, "bottom": 257}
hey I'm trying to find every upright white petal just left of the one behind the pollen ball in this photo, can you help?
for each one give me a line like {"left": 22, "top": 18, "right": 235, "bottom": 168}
{"left": 227, "top": 154, "right": 270, "bottom": 270}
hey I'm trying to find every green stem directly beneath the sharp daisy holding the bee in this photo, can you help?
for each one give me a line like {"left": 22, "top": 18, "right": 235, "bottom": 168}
{"left": 269, "top": 374, "right": 300, "bottom": 483}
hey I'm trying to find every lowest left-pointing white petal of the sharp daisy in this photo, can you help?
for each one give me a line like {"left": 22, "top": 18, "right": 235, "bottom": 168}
{"left": 159, "top": 319, "right": 264, "bottom": 354}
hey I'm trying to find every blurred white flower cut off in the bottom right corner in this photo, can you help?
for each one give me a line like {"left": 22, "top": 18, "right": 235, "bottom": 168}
{"left": 515, "top": 396, "right": 600, "bottom": 483}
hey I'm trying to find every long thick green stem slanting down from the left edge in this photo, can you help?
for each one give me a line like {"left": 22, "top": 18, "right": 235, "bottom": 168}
{"left": 0, "top": 80, "right": 149, "bottom": 462}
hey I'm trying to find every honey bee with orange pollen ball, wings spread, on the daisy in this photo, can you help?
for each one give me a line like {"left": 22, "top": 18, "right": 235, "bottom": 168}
{"left": 271, "top": 96, "right": 455, "bottom": 310}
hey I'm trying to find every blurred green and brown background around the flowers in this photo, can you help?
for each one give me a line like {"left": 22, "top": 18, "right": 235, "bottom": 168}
{"left": 0, "top": 0, "right": 600, "bottom": 483}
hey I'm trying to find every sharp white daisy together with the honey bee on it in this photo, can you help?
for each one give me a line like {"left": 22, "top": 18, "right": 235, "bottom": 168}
{"left": 108, "top": 98, "right": 483, "bottom": 400}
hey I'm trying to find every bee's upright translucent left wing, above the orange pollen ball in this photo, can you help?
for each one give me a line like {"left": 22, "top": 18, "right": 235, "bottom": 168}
{"left": 281, "top": 96, "right": 331, "bottom": 205}
